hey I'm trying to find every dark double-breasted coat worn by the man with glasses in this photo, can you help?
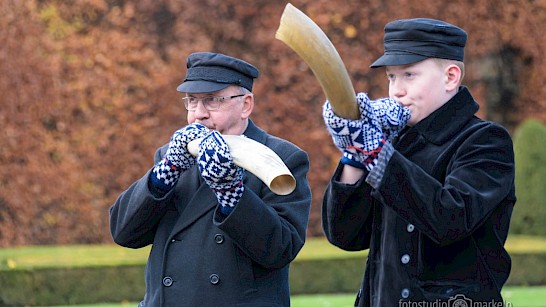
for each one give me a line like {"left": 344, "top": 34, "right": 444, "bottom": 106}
{"left": 110, "top": 122, "right": 311, "bottom": 307}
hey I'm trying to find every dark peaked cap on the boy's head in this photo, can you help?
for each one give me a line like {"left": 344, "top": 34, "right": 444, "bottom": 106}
{"left": 370, "top": 18, "right": 467, "bottom": 68}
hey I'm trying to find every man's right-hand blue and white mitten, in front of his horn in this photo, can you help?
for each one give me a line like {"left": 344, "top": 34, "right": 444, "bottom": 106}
{"left": 197, "top": 131, "right": 245, "bottom": 215}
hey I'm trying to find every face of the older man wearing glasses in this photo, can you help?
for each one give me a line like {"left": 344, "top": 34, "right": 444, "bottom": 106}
{"left": 187, "top": 86, "right": 250, "bottom": 135}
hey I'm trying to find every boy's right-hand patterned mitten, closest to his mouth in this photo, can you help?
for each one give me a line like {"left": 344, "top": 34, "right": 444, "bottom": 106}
{"left": 356, "top": 93, "right": 411, "bottom": 141}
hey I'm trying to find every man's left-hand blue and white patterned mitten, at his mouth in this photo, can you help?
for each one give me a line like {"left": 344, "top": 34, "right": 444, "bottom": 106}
{"left": 150, "top": 124, "right": 210, "bottom": 192}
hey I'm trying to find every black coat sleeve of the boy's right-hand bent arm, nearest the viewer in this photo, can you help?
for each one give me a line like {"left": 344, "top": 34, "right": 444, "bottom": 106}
{"left": 372, "top": 123, "right": 515, "bottom": 245}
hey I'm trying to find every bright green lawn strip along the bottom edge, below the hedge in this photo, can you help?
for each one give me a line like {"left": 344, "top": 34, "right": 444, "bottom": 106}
{"left": 46, "top": 286, "right": 546, "bottom": 307}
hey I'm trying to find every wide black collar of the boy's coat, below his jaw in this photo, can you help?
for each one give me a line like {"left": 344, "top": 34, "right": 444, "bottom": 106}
{"left": 408, "top": 86, "right": 479, "bottom": 145}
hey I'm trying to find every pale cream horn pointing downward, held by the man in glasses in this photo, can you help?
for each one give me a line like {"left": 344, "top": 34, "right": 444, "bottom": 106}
{"left": 188, "top": 135, "right": 296, "bottom": 195}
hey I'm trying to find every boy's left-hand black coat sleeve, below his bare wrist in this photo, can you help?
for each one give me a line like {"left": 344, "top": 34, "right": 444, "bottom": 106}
{"left": 322, "top": 163, "right": 374, "bottom": 251}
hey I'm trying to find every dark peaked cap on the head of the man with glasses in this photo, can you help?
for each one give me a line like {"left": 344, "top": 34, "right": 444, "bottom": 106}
{"left": 176, "top": 52, "right": 260, "bottom": 93}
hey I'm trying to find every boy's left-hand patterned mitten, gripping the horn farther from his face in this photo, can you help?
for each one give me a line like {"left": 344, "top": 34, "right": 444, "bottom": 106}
{"left": 322, "top": 99, "right": 386, "bottom": 171}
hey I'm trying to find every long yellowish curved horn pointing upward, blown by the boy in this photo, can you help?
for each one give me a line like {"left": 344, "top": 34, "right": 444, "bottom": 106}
{"left": 275, "top": 3, "right": 360, "bottom": 119}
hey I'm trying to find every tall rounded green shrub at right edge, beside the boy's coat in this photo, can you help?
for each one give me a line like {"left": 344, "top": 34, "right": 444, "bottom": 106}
{"left": 510, "top": 120, "right": 546, "bottom": 235}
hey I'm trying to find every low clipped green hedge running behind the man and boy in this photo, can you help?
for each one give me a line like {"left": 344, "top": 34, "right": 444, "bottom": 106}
{"left": 0, "top": 235, "right": 546, "bottom": 306}
